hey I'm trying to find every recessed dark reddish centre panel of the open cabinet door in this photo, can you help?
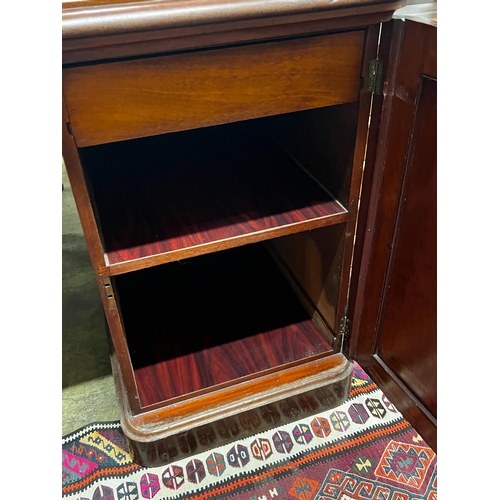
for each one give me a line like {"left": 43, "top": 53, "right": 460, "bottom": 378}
{"left": 377, "top": 78, "right": 437, "bottom": 416}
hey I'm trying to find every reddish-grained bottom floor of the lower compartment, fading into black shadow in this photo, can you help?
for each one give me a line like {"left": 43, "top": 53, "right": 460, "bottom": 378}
{"left": 115, "top": 244, "right": 332, "bottom": 407}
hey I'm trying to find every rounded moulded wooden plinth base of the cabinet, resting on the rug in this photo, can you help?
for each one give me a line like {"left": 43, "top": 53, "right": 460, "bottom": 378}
{"left": 112, "top": 354, "right": 353, "bottom": 466}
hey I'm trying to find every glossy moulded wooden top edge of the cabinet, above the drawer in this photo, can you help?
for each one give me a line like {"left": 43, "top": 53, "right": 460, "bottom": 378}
{"left": 62, "top": 0, "right": 405, "bottom": 39}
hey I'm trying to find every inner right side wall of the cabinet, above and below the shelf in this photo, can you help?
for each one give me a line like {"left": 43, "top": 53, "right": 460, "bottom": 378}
{"left": 266, "top": 102, "right": 359, "bottom": 334}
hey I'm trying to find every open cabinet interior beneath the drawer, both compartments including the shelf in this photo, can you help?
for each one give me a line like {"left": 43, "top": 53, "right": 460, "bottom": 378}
{"left": 79, "top": 103, "right": 358, "bottom": 407}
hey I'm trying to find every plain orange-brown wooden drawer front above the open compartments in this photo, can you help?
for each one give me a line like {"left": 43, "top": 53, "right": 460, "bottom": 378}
{"left": 63, "top": 31, "right": 364, "bottom": 147}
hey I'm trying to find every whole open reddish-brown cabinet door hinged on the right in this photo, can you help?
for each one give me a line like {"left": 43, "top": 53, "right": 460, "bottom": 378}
{"left": 349, "top": 14, "right": 437, "bottom": 449}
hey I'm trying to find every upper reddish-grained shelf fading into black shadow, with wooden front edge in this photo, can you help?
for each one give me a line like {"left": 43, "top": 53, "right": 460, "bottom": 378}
{"left": 82, "top": 122, "right": 347, "bottom": 274}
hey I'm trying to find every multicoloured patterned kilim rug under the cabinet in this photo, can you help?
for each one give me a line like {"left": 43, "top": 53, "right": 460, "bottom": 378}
{"left": 62, "top": 365, "right": 437, "bottom": 500}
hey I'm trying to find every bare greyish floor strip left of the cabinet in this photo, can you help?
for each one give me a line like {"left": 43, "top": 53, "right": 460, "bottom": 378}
{"left": 62, "top": 163, "right": 119, "bottom": 436}
